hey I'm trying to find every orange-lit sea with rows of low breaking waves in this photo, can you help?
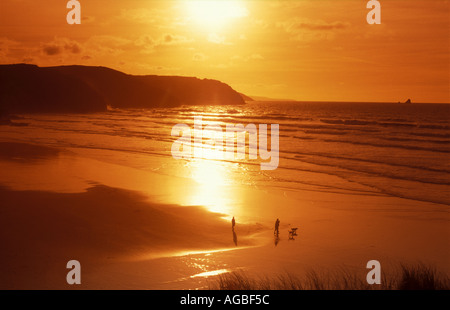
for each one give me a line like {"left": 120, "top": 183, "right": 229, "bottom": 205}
{"left": 0, "top": 101, "right": 450, "bottom": 206}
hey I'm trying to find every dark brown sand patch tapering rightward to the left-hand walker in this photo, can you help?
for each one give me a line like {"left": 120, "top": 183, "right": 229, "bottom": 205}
{"left": 0, "top": 185, "right": 264, "bottom": 289}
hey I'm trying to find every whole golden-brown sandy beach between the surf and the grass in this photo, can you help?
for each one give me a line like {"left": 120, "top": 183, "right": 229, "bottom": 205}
{"left": 0, "top": 142, "right": 450, "bottom": 289}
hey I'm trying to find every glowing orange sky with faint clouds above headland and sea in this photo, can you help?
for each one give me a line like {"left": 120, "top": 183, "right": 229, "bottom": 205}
{"left": 0, "top": 0, "right": 450, "bottom": 103}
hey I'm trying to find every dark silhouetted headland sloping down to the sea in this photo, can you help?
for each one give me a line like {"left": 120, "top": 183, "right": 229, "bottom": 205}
{"left": 0, "top": 64, "right": 245, "bottom": 114}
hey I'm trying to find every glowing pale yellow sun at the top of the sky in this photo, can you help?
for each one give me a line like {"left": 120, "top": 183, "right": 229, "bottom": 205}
{"left": 186, "top": 0, "right": 248, "bottom": 27}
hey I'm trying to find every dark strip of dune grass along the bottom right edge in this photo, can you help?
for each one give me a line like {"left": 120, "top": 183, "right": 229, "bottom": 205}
{"left": 208, "top": 263, "right": 450, "bottom": 290}
